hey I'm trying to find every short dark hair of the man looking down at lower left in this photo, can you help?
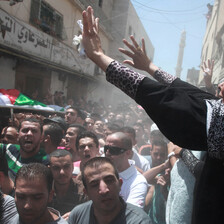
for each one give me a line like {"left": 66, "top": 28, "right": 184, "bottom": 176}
{"left": 15, "top": 163, "right": 53, "bottom": 192}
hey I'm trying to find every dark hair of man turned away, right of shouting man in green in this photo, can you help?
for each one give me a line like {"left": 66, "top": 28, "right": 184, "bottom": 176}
{"left": 44, "top": 122, "right": 63, "bottom": 146}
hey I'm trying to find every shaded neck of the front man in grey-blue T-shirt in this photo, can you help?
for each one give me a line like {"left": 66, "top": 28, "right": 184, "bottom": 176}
{"left": 94, "top": 201, "right": 122, "bottom": 224}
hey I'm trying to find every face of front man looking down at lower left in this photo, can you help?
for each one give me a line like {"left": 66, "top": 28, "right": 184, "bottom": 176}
{"left": 15, "top": 178, "right": 52, "bottom": 224}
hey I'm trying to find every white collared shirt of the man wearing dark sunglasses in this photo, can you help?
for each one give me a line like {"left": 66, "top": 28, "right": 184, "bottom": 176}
{"left": 119, "top": 160, "right": 148, "bottom": 208}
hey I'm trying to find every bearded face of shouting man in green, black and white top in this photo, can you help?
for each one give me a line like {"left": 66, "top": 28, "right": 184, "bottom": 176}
{"left": 19, "top": 121, "right": 42, "bottom": 157}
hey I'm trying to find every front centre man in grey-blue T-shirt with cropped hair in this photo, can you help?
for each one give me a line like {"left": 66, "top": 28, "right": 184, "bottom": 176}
{"left": 68, "top": 157, "right": 151, "bottom": 224}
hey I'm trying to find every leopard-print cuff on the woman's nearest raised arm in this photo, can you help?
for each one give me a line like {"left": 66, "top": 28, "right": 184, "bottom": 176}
{"left": 106, "top": 61, "right": 146, "bottom": 99}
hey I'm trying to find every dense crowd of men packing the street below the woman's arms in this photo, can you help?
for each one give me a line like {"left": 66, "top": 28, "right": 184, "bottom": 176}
{"left": 0, "top": 99, "right": 175, "bottom": 223}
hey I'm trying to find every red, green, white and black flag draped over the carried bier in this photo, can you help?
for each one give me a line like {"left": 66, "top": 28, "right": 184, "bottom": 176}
{"left": 0, "top": 89, "right": 64, "bottom": 111}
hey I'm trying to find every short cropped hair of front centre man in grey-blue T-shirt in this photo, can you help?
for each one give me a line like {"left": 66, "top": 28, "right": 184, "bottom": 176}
{"left": 81, "top": 157, "right": 119, "bottom": 189}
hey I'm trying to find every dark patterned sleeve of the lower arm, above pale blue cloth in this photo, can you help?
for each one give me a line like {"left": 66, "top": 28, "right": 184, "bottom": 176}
{"left": 180, "top": 149, "right": 204, "bottom": 179}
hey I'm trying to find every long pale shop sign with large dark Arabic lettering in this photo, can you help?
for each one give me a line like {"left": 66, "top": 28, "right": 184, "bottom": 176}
{"left": 0, "top": 9, "right": 76, "bottom": 68}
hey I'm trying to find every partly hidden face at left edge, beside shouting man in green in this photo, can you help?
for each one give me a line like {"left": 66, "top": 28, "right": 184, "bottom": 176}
{"left": 1, "top": 127, "right": 18, "bottom": 144}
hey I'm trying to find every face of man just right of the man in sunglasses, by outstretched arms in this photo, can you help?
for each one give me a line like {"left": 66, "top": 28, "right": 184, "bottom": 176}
{"left": 151, "top": 145, "right": 167, "bottom": 166}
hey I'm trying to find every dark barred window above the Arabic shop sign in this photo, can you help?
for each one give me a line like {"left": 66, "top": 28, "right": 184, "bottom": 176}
{"left": 30, "top": 0, "right": 65, "bottom": 39}
